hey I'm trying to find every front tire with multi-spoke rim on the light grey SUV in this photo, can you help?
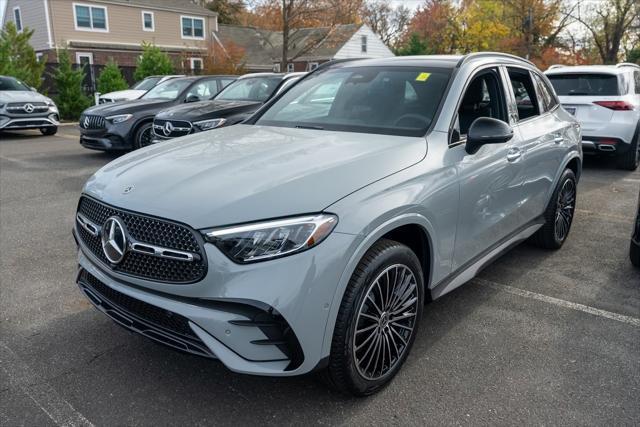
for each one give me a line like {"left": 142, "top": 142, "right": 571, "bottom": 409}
{"left": 322, "top": 239, "right": 424, "bottom": 396}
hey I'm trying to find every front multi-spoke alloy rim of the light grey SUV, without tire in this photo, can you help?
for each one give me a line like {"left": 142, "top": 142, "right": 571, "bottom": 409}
{"left": 353, "top": 264, "right": 419, "bottom": 380}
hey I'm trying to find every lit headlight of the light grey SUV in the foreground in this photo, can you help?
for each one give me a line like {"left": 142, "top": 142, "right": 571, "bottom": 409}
{"left": 205, "top": 214, "right": 338, "bottom": 263}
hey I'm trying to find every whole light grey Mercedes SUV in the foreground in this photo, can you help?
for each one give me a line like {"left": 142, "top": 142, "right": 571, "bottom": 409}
{"left": 74, "top": 53, "right": 582, "bottom": 395}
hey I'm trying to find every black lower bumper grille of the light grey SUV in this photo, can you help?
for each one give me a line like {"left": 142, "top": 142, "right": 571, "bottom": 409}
{"left": 78, "top": 269, "right": 212, "bottom": 357}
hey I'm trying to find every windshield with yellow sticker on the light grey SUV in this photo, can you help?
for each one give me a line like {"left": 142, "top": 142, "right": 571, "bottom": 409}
{"left": 256, "top": 67, "right": 451, "bottom": 136}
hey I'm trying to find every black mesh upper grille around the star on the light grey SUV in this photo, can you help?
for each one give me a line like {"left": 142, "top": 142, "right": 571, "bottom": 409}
{"left": 77, "top": 196, "right": 207, "bottom": 283}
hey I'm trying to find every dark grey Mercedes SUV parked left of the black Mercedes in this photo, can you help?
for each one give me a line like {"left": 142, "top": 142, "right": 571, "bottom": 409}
{"left": 80, "top": 76, "right": 236, "bottom": 151}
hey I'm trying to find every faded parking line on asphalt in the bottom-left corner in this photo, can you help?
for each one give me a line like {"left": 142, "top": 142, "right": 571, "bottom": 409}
{"left": 0, "top": 341, "right": 93, "bottom": 427}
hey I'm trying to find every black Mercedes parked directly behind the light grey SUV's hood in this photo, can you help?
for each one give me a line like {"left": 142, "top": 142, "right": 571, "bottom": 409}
{"left": 153, "top": 73, "right": 306, "bottom": 142}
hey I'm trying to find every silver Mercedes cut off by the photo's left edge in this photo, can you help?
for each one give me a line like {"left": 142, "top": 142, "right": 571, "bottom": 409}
{"left": 0, "top": 76, "right": 60, "bottom": 135}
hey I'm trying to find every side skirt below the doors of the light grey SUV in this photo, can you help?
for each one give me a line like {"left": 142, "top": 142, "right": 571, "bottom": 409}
{"left": 431, "top": 218, "right": 544, "bottom": 299}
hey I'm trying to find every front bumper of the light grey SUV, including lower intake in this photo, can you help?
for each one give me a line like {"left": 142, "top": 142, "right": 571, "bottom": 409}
{"left": 78, "top": 222, "right": 355, "bottom": 376}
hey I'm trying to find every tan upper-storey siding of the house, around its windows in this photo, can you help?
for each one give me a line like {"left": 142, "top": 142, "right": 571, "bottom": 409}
{"left": 47, "top": 0, "right": 216, "bottom": 50}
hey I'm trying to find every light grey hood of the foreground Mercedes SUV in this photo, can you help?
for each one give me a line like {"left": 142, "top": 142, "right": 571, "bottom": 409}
{"left": 84, "top": 124, "right": 427, "bottom": 228}
